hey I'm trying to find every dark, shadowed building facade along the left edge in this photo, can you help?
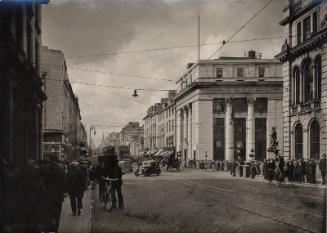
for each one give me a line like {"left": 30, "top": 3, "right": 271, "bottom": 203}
{"left": 0, "top": 1, "right": 47, "bottom": 166}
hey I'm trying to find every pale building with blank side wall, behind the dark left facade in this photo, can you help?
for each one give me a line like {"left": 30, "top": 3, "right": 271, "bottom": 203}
{"left": 41, "top": 46, "right": 85, "bottom": 160}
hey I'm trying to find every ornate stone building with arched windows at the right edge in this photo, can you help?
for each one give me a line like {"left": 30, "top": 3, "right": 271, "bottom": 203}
{"left": 276, "top": 0, "right": 327, "bottom": 160}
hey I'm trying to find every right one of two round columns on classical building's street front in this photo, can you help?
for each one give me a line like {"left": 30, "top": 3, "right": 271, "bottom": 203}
{"left": 246, "top": 97, "right": 255, "bottom": 161}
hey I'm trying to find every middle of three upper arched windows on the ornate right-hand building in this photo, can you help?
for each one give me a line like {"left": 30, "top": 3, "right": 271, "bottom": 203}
{"left": 302, "top": 58, "right": 313, "bottom": 102}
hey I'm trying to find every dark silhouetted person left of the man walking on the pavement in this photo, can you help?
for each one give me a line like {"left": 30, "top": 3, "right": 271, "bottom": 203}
{"left": 44, "top": 154, "right": 67, "bottom": 232}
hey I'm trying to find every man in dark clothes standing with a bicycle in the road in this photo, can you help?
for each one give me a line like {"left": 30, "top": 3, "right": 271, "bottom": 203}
{"left": 110, "top": 160, "right": 124, "bottom": 209}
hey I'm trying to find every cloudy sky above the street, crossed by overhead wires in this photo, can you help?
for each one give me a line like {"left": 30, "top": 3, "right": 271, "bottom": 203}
{"left": 42, "top": 0, "right": 286, "bottom": 144}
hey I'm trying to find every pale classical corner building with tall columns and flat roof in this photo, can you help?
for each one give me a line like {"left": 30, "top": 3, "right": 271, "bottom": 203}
{"left": 175, "top": 51, "right": 283, "bottom": 160}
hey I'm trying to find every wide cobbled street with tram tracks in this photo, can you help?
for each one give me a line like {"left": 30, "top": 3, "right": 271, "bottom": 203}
{"left": 91, "top": 170, "right": 326, "bottom": 233}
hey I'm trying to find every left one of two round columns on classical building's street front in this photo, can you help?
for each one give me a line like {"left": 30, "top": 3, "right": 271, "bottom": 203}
{"left": 225, "top": 99, "right": 234, "bottom": 161}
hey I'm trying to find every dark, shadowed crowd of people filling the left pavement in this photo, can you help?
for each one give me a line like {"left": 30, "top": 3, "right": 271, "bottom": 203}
{"left": 1, "top": 156, "right": 88, "bottom": 233}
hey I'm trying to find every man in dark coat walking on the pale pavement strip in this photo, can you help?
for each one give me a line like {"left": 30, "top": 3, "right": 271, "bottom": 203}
{"left": 67, "top": 161, "right": 85, "bottom": 216}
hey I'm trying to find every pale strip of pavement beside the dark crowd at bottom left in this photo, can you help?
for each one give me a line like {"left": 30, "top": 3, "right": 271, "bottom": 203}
{"left": 58, "top": 188, "right": 93, "bottom": 233}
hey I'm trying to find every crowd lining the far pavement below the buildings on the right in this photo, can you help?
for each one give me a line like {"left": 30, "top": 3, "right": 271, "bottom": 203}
{"left": 177, "top": 154, "right": 326, "bottom": 184}
